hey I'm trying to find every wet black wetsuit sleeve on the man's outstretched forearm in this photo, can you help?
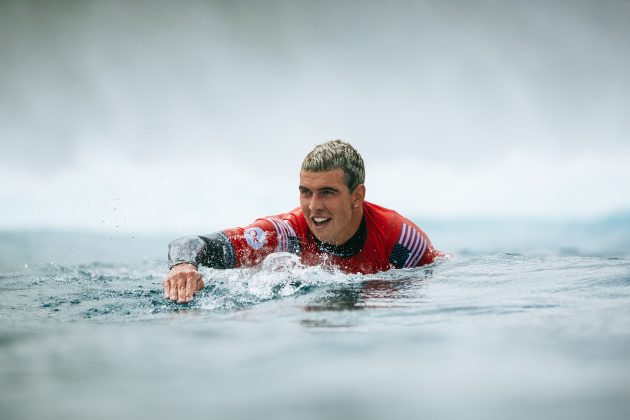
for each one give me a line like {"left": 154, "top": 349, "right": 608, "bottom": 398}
{"left": 168, "top": 232, "right": 236, "bottom": 269}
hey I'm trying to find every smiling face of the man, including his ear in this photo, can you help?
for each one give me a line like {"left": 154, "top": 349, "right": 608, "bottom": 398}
{"left": 300, "top": 169, "right": 365, "bottom": 245}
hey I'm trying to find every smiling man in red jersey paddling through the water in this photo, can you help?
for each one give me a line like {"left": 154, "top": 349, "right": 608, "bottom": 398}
{"left": 164, "top": 140, "right": 443, "bottom": 303}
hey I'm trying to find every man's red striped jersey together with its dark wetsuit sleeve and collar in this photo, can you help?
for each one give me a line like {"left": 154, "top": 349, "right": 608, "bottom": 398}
{"left": 169, "top": 202, "right": 443, "bottom": 274}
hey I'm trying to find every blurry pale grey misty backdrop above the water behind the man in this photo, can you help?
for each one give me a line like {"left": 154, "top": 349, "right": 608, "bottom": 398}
{"left": 0, "top": 0, "right": 630, "bottom": 240}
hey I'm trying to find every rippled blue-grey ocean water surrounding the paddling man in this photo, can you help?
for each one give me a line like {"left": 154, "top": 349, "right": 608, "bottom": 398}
{"left": 0, "top": 218, "right": 630, "bottom": 419}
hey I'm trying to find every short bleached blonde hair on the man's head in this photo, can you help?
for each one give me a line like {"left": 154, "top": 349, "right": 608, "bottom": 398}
{"left": 302, "top": 140, "right": 365, "bottom": 191}
